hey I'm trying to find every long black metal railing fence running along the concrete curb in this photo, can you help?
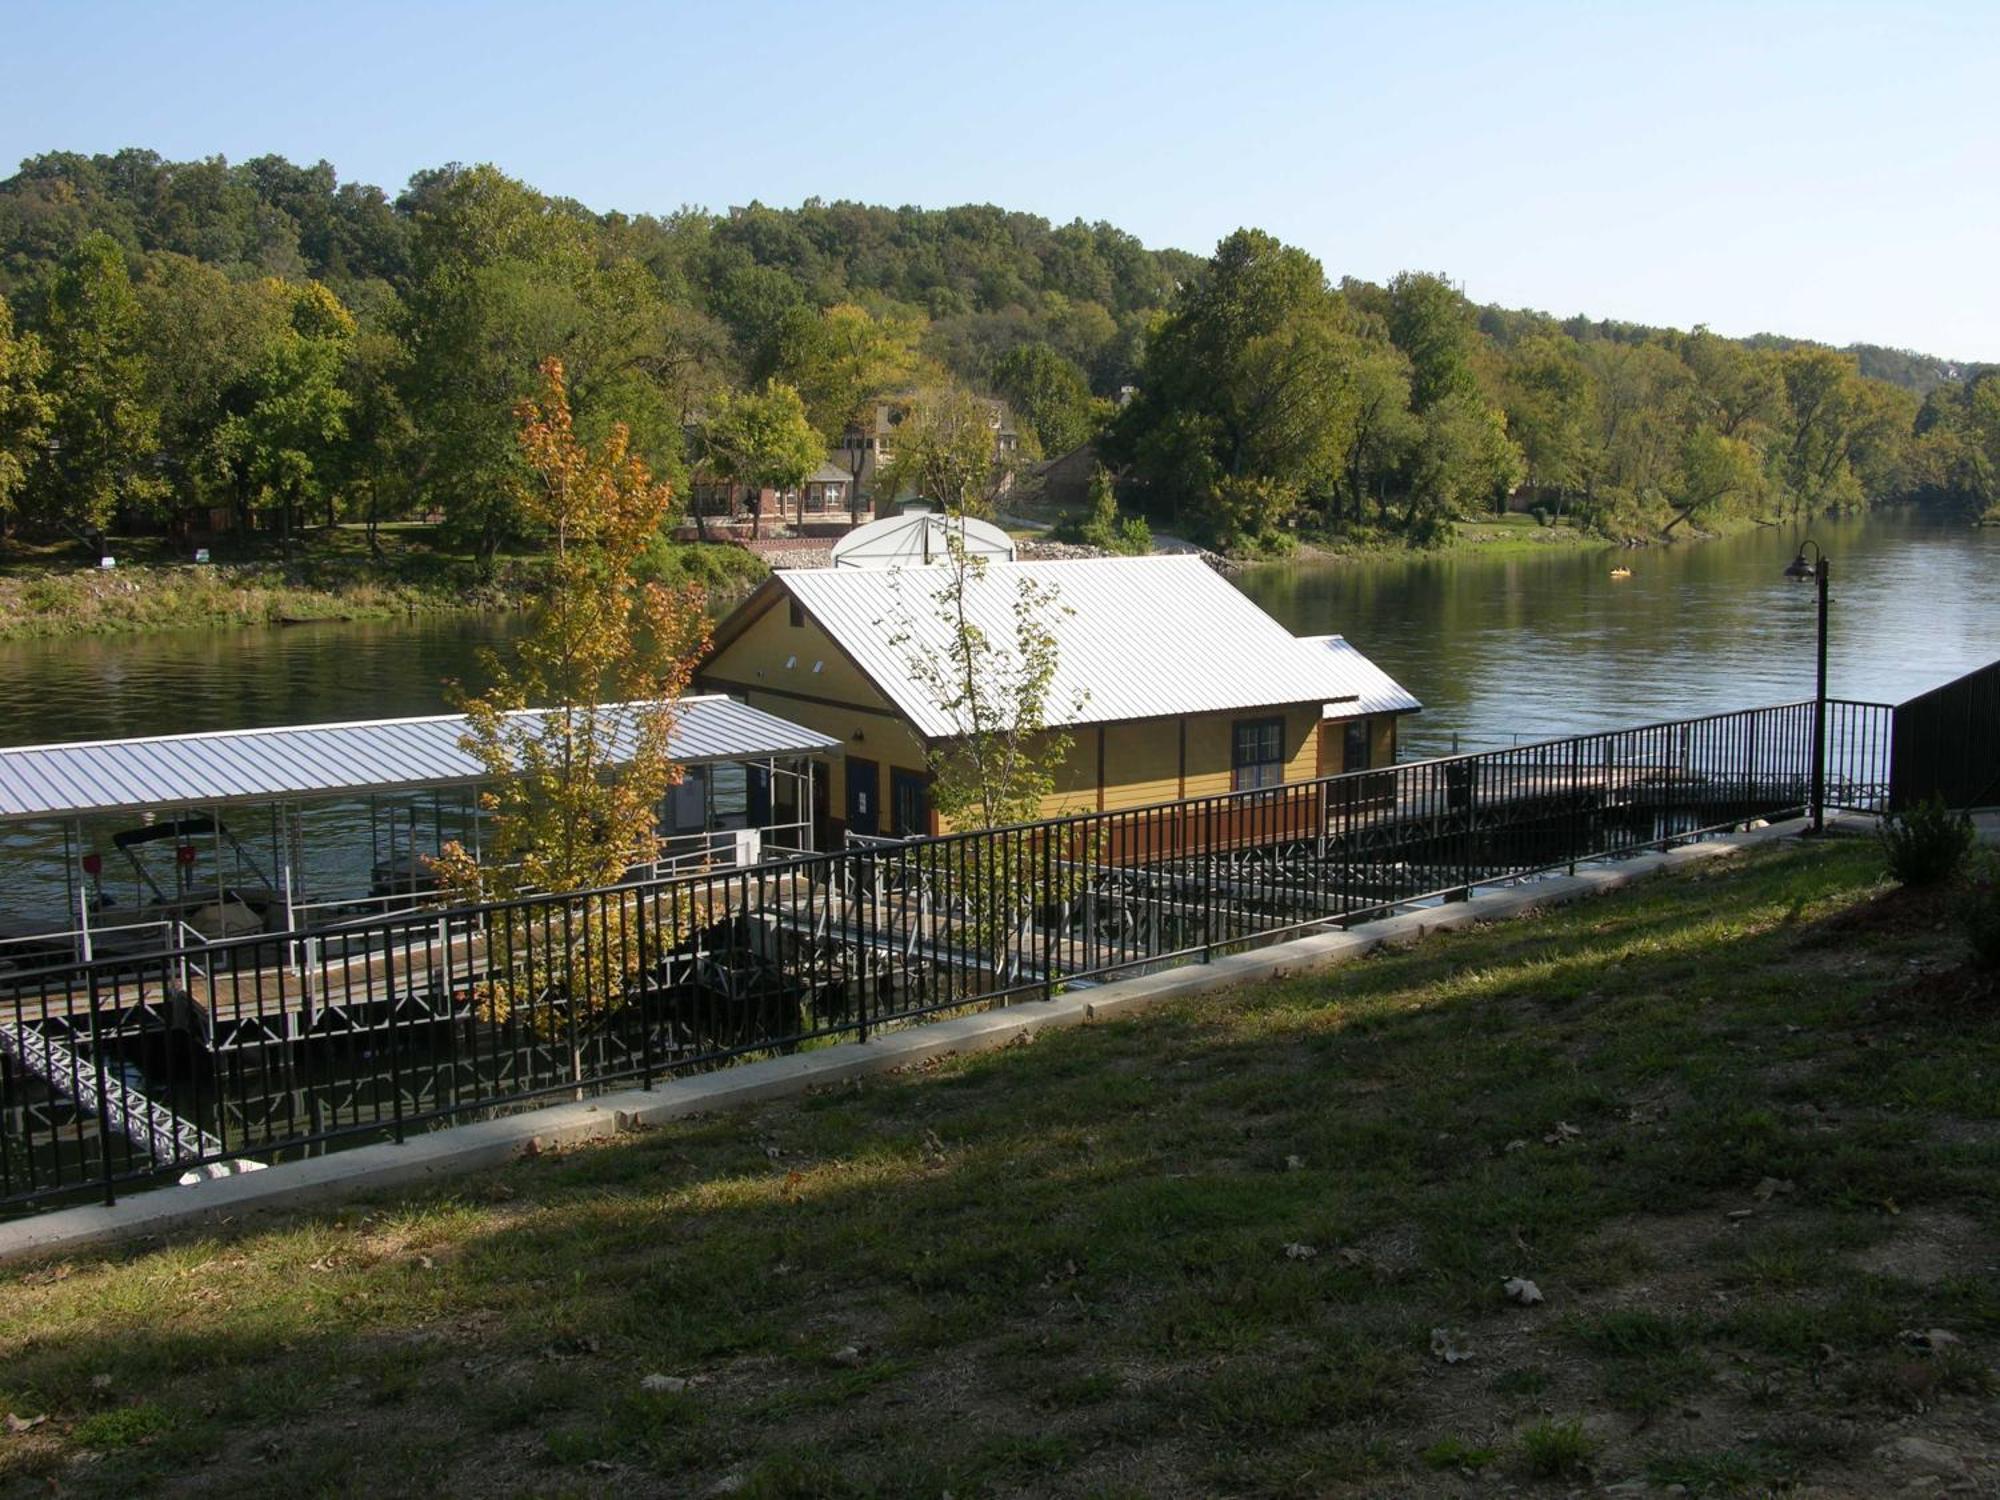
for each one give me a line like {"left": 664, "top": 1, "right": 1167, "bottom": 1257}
{"left": 0, "top": 702, "right": 1890, "bottom": 1208}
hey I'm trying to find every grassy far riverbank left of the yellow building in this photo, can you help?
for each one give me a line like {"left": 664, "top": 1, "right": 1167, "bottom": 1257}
{"left": 0, "top": 526, "right": 764, "bottom": 640}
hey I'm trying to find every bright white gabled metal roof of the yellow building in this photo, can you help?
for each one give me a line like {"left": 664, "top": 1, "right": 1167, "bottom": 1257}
{"left": 774, "top": 556, "right": 1416, "bottom": 738}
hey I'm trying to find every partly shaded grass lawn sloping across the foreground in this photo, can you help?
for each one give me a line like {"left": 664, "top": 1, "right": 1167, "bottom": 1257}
{"left": 0, "top": 842, "right": 2000, "bottom": 1500}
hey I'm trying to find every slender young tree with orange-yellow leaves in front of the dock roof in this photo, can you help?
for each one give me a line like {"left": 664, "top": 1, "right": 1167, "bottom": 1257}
{"left": 438, "top": 358, "right": 708, "bottom": 1082}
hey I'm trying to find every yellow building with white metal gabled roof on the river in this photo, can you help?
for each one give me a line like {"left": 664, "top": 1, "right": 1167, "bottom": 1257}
{"left": 698, "top": 556, "right": 1420, "bottom": 838}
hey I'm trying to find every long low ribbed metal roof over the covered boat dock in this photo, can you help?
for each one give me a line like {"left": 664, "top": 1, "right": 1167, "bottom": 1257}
{"left": 0, "top": 694, "right": 840, "bottom": 822}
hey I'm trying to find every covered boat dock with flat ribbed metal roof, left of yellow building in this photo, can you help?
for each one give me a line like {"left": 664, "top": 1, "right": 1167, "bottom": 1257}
{"left": 0, "top": 694, "right": 842, "bottom": 966}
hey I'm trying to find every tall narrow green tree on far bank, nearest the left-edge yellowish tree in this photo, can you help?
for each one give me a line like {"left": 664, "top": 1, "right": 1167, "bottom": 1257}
{"left": 26, "top": 234, "right": 166, "bottom": 548}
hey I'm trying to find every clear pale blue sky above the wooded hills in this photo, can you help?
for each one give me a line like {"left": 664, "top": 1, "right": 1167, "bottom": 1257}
{"left": 15, "top": 0, "right": 2000, "bottom": 360}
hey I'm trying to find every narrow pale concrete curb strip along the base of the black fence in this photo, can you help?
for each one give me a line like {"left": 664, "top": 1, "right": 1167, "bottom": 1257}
{"left": 0, "top": 816, "right": 1840, "bottom": 1262}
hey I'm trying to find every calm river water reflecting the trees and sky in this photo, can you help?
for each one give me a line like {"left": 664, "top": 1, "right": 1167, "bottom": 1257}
{"left": 0, "top": 516, "right": 2000, "bottom": 916}
